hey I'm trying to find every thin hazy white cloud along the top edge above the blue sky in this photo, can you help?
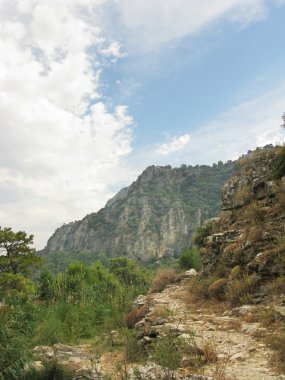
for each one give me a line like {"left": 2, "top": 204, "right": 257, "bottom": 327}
{"left": 113, "top": 0, "right": 280, "bottom": 52}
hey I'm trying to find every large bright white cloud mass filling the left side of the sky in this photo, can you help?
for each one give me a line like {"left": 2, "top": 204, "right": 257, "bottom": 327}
{"left": 0, "top": 0, "right": 133, "bottom": 248}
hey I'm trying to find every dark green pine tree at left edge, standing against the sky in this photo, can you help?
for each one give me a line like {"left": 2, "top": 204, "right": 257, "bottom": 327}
{"left": 0, "top": 227, "right": 41, "bottom": 275}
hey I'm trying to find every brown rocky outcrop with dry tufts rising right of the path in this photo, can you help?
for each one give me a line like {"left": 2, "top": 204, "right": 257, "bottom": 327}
{"left": 201, "top": 147, "right": 285, "bottom": 280}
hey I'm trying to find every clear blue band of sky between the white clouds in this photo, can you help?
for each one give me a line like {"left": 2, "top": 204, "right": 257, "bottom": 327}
{"left": 103, "top": 2, "right": 285, "bottom": 155}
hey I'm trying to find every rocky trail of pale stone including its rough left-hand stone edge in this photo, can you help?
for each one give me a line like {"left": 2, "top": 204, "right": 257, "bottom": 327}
{"left": 130, "top": 279, "right": 285, "bottom": 380}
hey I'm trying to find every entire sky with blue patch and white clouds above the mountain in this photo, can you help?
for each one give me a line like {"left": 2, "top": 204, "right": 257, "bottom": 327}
{"left": 0, "top": 0, "right": 285, "bottom": 249}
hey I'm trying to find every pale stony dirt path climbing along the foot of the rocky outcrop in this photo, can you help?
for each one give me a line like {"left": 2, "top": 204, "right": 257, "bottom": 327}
{"left": 136, "top": 280, "right": 285, "bottom": 380}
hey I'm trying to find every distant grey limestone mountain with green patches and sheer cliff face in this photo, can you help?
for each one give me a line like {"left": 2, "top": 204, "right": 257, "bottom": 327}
{"left": 43, "top": 162, "right": 235, "bottom": 260}
